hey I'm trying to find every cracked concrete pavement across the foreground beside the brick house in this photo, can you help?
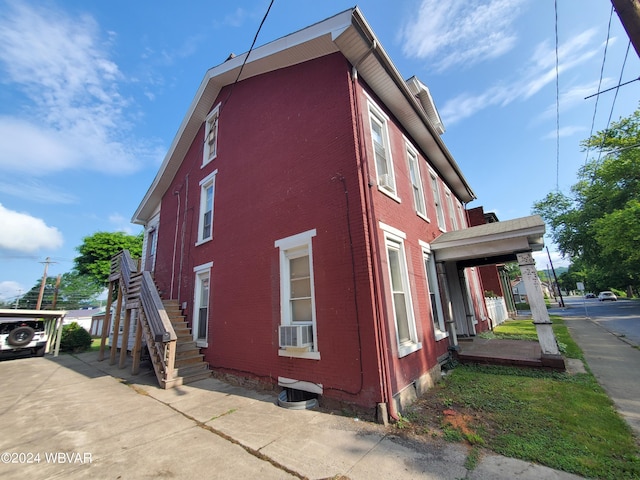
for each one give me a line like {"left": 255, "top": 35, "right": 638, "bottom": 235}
{"left": 0, "top": 352, "right": 579, "bottom": 480}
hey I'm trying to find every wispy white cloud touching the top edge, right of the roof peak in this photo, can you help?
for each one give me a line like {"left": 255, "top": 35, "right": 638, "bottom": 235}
{"left": 401, "top": 0, "right": 524, "bottom": 72}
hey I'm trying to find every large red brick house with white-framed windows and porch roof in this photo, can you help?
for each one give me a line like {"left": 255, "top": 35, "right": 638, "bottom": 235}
{"left": 123, "top": 8, "right": 560, "bottom": 416}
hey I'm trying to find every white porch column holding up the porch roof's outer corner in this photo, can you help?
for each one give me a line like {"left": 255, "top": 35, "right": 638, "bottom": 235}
{"left": 516, "top": 252, "right": 564, "bottom": 369}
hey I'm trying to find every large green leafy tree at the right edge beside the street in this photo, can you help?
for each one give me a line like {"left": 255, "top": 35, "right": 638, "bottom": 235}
{"left": 534, "top": 106, "right": 640, "bottom": 291}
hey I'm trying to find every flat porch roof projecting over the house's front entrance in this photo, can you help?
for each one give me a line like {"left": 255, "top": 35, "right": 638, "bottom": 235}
{"left": 431, "top": 215, "right": 545, "bottom": 267}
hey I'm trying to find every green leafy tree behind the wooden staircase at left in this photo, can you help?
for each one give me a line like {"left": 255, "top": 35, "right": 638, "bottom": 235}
{"left": 74, "top": 232, "right": 143, "bottom": 286}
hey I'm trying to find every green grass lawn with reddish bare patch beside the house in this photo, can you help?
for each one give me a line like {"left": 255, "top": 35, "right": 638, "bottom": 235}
{"left": 398, "top": 317, "right": 640, "bottom": 479}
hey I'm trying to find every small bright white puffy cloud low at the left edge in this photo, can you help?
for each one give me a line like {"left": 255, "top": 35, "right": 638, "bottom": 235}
{"left": 0, "top": 204, "right": 63, "bottom": 253}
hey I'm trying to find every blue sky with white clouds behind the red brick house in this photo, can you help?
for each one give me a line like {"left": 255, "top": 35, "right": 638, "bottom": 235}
{"left": 0, "top": 0, "right": 640, "bottom": 299}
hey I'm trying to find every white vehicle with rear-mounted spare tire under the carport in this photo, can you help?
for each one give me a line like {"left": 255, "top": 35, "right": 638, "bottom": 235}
{"left": 0, "top": 318, "right": 47, "bottom": 357}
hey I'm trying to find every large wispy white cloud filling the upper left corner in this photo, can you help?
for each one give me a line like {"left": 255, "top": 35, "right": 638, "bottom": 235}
{"left": 0, "top": 2, "right": 151, "bottom": 175}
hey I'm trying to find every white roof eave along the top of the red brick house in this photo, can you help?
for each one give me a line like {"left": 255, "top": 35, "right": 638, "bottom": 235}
{"left": 131, "top": 7, "right": 476, "bottom": 225}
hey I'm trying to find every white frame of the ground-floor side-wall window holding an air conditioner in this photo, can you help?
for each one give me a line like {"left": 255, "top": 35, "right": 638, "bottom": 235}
{"left": 274, "top": 229, "right": 320, "bottom": 360}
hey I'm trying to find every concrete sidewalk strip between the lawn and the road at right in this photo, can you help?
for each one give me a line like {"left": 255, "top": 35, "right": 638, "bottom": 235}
{"left": 560, "top": 314, "right": 640, "bottom": 443}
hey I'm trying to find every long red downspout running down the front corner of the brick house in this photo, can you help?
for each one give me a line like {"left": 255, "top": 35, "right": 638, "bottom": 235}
{"left": 351, "top": 39, "right": 399, "bottom": 422}
